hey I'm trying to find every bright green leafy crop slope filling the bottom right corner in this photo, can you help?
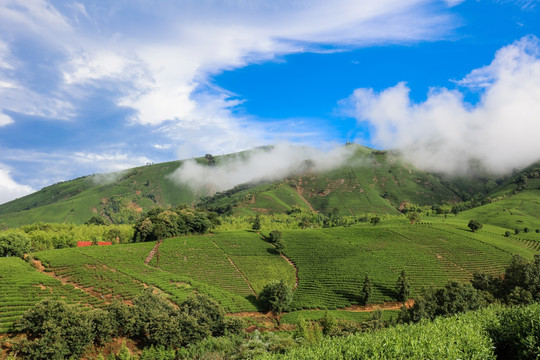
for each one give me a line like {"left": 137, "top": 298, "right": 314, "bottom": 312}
{"left": 261, "top": 304, "right": 540, "bottom": 360}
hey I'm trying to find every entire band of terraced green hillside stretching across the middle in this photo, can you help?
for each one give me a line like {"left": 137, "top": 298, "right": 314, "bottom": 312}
{"left": 0, "top": 217, "right": 540, "bottom": 331}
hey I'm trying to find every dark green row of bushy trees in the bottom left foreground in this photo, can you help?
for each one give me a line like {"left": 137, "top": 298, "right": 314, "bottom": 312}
{"left": 15, "top": 290, "right": 244, "bottom": 359}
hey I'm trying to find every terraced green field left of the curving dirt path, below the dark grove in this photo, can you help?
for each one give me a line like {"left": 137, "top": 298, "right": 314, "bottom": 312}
{"left": 29, "top": 231, "right": 295, "bottom": 312}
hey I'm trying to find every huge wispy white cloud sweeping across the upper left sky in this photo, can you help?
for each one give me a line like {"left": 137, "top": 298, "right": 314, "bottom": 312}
{"left": 0, "top": 0, "right": 464, "bottom": 202}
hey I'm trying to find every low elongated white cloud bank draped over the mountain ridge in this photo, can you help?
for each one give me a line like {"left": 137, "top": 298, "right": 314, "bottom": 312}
{"left": 170, "top": 144, "right": 353, "bottom": 195}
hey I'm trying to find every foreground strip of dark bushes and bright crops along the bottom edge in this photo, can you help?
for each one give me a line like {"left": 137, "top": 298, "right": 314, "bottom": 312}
{"left": 5, "top": 294, "right": 540, "bottom": 360}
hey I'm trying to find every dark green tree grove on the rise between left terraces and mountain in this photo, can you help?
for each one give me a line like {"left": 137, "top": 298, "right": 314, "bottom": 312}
{"left": 133, "top": 206, "right": 219, "bottom": 242}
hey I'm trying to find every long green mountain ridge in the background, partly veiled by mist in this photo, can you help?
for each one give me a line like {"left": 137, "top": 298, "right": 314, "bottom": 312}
{"left": 0, "top": 144, "right": 498, "bottom": 227}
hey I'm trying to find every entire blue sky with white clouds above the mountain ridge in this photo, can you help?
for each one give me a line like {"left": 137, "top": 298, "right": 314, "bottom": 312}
{"left": 0, "top": 0, "right": 540, "bottom": 203}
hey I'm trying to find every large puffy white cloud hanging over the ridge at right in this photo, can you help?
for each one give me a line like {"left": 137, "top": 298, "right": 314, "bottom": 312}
{"left": 343, "top": 37, "right": 540, "bottom": 173}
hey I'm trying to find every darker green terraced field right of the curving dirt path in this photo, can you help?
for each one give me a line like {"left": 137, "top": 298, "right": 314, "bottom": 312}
{"left": 284, "top": 224, "right": 537, "bottom": 309}
